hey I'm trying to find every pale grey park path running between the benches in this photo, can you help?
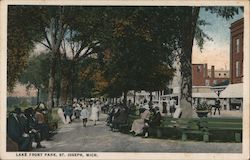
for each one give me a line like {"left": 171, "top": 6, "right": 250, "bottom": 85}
{"left": 33, "top": 115, "right": 242, "bottom": 153}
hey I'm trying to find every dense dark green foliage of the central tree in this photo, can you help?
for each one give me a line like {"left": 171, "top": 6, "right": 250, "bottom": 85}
{"left": 102, "top": 7, "right": 175, "bottom": 105}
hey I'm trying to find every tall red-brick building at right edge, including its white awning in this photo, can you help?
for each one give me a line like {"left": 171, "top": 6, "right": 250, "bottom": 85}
{"left": 220, "top": 18, "right": 244, "bottom": 110}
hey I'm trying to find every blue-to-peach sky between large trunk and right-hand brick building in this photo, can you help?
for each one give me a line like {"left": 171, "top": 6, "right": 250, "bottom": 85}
{"left": 192, "top": 9, "right": 243, "bottom": 70}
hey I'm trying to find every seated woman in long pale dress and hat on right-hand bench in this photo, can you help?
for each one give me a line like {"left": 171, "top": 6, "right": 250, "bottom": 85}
{"left": 131, "top": 110, "right": 150, "bottom": 135}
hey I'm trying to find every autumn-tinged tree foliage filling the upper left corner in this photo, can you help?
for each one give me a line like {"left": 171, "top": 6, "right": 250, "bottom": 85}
{"left": 7, "top": 6, "right": 41, "bottom": 92}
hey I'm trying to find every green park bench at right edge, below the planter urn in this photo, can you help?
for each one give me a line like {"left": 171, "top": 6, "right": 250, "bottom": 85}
{"left": 198, "top": 118, "right": 242, "bottom": 142}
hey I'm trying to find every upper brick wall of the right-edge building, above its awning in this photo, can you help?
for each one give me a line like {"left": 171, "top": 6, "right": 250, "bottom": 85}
{"left": 230, "top": 18, "right": 244, "bottom": 84}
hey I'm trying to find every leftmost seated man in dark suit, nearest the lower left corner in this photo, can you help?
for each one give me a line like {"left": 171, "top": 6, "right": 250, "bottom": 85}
{"left": 7, "top": 108, "right": 32, "bottom": 151}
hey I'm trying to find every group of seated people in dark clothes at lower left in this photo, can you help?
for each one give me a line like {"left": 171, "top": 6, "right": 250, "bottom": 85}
{"left": 7, "top": 103, "right": 50, "bottom": 151}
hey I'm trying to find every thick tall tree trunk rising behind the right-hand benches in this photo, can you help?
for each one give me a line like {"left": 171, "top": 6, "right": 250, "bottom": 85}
{"left": 180, "top": 7, "right": 200, "bottom": 118}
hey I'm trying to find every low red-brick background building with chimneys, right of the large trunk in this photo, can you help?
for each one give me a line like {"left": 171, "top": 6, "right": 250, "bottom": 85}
{"left": 192, "top": 64, "right": 230, "bottom": 86}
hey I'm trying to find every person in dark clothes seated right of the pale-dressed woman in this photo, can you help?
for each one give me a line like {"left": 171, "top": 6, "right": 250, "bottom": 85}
{"left": 143, "top": 107, "right": 161, "bottom": 137}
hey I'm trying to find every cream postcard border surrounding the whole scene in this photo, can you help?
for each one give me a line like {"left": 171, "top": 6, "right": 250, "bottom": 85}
{"left": 0, "top": 0, "right": 250, "bottom": 160}
